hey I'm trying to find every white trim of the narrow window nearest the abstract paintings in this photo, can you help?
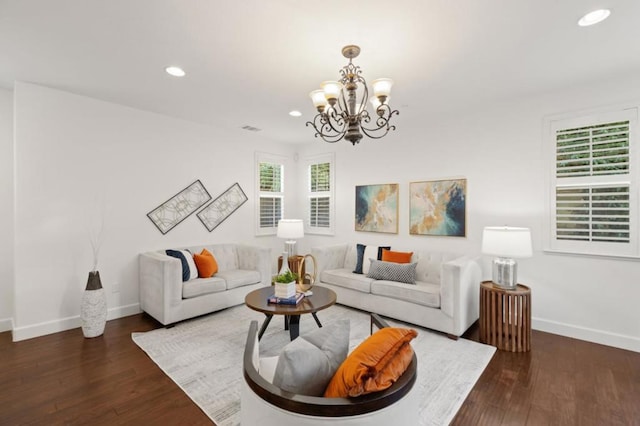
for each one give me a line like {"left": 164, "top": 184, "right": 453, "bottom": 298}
{"left": 304, "top": 152, "right": 336, "bottom": 235}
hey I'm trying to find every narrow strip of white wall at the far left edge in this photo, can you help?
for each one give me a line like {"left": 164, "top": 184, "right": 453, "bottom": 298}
{"left": 0, "top": 89, "right": 13, "bottom": 332}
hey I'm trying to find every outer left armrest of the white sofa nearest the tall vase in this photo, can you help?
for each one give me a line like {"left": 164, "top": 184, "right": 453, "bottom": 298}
{"left": 138, "top": 252, "right": 182, "bottom": 324}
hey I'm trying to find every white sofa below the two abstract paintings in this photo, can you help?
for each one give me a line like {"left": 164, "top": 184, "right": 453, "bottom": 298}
{"left": 311, "top": 244, "right": 481, "bottom": 339}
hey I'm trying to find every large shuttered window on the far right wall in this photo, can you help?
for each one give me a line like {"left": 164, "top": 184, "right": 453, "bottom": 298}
{"left": 547, "top": 108, "right": 640, "bottom": 257}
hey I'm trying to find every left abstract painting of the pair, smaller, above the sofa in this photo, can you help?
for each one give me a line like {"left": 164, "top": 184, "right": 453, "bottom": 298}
{"left": 355, "top": 183, "right": 398, "bottom": 234}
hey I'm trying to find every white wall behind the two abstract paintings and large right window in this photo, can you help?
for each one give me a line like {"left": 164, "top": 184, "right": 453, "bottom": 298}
{"left": 298, "top": 74, "right": 640, "bottom": 351}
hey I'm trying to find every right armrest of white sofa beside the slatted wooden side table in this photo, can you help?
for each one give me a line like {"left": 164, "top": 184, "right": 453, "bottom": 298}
{"left": 440, "top": 256, "right": 482, "bottom": 335}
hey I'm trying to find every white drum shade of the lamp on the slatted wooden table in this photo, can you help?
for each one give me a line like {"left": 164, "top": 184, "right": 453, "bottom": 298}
{"left": 482, "top": 226, "right": 533, "bottom": 258}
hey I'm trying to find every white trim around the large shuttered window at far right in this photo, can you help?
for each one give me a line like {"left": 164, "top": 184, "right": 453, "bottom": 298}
{"left": 543, "top": 104, "right": 640, "bottom": 259}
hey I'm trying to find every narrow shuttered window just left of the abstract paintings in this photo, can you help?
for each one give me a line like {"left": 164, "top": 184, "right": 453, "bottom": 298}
{"left": 305, "top": 154, "right": 334, "bottom": 235}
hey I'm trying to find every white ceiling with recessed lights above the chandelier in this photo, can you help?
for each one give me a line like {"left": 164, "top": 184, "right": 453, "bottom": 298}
{"left": 0, "top": 0, "right": 640, "bottom": 143}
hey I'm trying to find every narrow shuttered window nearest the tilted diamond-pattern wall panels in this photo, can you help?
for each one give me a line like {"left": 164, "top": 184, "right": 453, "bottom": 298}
{"left": 256, "top": 153, "right": 284, "bottom": 235}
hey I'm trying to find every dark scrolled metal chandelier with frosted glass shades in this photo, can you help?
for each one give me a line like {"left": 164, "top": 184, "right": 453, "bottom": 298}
{"left": 306, "top": 45, "right": 398, "bottom": 145}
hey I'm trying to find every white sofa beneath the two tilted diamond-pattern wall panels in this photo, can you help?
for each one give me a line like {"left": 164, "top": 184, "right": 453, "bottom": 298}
{"left": 139, "top": 244, "right": 271, "bottom": 325}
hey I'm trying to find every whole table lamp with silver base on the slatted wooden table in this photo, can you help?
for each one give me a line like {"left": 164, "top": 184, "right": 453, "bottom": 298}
{"left": 482, "top": 226, "right": 533, "bottom": 290}
